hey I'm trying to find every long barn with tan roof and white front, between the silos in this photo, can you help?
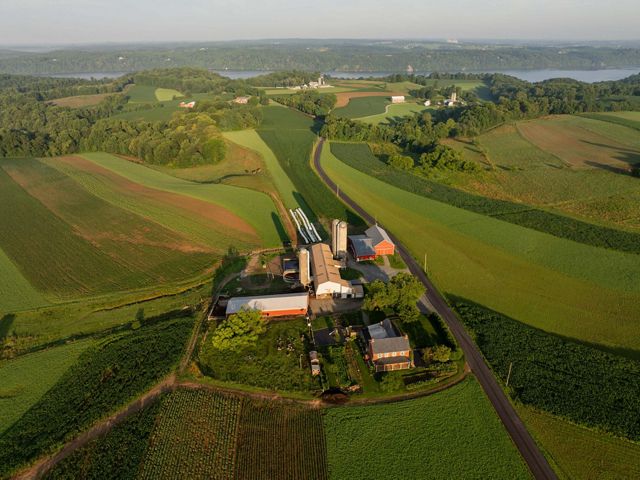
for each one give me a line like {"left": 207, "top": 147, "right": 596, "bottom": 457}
{"left": 311, "top": 243, "right": 354, "bottom": 298}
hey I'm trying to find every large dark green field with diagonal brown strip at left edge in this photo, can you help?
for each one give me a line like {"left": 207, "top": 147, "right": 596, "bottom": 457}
{"left": 2, "top": 159, "right": 214, "bottom": 298}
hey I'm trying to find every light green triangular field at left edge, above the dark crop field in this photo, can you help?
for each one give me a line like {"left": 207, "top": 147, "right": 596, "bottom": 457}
{"left": 0, "top": 340, "right": 93, "bottom": 435}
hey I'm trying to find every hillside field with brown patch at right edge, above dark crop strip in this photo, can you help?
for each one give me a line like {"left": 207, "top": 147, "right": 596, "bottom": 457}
{"left": 447, "top": 117, "right": 640, "bottom": 230}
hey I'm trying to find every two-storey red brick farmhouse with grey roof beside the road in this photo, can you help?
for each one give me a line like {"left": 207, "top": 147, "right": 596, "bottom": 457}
{"left": 365, "top": 318, "right": 413, "bottom": 372}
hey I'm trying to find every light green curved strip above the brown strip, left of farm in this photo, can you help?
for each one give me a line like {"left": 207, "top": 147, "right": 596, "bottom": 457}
{"left": 83, "top": 153, "right": 281, "bottom": 247}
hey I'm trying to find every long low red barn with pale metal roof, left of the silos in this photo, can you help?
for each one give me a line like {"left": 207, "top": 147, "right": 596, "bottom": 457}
{"left": 226, "top": 292, "right": 309, "bottom": 317}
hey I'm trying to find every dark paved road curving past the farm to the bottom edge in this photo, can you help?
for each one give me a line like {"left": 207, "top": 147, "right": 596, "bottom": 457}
{"left": 313, "top": 139, "right": 557, "bottom": 479}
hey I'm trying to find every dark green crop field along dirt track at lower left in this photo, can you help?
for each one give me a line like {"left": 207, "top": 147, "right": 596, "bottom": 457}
{"left": 0, "top": 317, "right": 194, "bottom": 477}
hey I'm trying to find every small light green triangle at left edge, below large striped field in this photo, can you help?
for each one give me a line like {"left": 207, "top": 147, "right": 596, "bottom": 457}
{"left": 0, "top": 249, "right": 49, "bottom": 314}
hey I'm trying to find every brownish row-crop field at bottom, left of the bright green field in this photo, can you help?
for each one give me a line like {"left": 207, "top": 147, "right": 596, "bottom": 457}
{"left": 140, "top": 390, "right": 326, "bottom": 480}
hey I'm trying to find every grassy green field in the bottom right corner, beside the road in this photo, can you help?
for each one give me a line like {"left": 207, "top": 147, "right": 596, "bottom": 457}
{"left": 517, "top": 406, "right": 640, "bottom": 480}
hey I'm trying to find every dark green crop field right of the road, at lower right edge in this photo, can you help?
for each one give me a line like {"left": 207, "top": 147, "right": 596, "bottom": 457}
{"left": 456, "top": 302, "right": 640, "bottom": 441}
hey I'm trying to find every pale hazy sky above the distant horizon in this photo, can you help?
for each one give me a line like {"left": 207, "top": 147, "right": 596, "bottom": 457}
{"left": 0, "top": 0, "right": 640, "bottom": 45}
